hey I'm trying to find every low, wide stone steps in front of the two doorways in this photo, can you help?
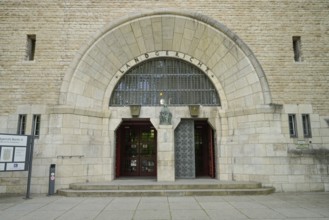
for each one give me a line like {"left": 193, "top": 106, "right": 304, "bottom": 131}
{"left": 57, "top": 179, "right": 275, "bottom": 197}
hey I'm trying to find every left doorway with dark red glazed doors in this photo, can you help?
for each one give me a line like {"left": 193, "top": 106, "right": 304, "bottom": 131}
{"left": 116, "top": 120, "right": 157, "bottom": 177}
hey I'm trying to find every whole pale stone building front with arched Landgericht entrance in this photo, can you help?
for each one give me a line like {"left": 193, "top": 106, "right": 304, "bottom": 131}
{"left": 0, "top": 0, "right": 329, "bottom": 193}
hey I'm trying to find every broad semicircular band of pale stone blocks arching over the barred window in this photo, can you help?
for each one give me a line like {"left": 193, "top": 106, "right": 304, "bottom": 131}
{"left": 59, "top": 10, "right": 271, "bottom": 111}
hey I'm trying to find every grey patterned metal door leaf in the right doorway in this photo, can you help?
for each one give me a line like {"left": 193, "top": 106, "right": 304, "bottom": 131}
{"left": 175, "top": 120, "right": 195, "bottom": 178}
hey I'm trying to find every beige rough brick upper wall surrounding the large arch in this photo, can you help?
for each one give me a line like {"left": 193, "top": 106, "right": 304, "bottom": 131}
{"left": 0, "top": 0, "right": 329, "bottom": 115}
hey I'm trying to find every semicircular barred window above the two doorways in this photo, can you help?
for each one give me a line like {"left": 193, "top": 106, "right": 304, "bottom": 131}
{"left": 110, "top": 58, "right": 220, "bottom": 106}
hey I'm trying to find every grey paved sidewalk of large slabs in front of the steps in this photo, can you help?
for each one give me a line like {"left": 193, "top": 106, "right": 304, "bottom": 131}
{"left": 0, "top": 192, "right": 329, "bottom": 220}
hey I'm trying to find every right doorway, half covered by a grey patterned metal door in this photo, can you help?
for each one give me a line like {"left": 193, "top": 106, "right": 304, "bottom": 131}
{"left": 175, "top": 119, "right": 215, "bottom": 178}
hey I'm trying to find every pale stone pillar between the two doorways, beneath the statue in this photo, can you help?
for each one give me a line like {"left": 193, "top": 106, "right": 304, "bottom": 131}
{"left": 157, "top": 125, "right": 175, "bottom": 182}
